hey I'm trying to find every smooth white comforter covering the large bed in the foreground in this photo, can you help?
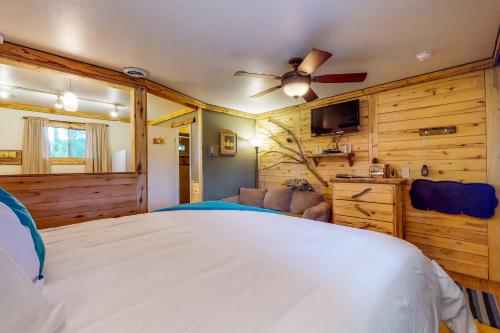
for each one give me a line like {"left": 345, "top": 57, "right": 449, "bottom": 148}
{"left": 42, "top": 211, "right": 475, "bottom": 333}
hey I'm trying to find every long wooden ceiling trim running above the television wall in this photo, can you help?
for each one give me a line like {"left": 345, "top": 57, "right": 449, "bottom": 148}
{"left": 256, "top": 58, "right": 494, "bottom": 119}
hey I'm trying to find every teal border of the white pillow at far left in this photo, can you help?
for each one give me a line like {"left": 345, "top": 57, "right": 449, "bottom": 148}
{"left": 0, "top": 188, "right": 45, "bottom": 278}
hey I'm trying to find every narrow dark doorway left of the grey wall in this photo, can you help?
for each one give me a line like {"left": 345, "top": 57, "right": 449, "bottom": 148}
{"left": 178, "top": 125, "right": 191, "bottom": 203}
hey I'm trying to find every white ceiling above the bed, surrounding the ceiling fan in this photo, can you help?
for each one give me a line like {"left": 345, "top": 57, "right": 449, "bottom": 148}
{"left": 0, "top": 0, "right": 500, "bottom": 113}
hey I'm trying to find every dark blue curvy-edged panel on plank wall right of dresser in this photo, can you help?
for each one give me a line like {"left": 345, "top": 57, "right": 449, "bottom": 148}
{"left": 410, "top": 179, "right": 498, "bottom": 219}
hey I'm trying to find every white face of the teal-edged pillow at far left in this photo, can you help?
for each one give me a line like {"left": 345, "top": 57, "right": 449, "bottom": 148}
{"left": 0, "top": 202, "right": 40, "bottom": 281}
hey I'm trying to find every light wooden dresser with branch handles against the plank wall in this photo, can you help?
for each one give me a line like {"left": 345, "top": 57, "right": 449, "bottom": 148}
{"left": 333, "top": 178, "right": 406, "bottom": 238}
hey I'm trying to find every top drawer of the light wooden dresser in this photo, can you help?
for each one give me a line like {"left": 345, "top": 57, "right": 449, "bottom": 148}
{"left": 333, "top": 183, "right": 394, "bottom": 205}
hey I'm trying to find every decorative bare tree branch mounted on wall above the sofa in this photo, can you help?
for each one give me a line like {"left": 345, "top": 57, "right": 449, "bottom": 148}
{"left": 261, "top": 119, "right": 328, "bottom": 186}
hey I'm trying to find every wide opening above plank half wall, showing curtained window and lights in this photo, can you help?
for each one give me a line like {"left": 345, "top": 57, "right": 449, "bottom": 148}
{"left": 0, "top": 64, "right": 134, "bottom": 175}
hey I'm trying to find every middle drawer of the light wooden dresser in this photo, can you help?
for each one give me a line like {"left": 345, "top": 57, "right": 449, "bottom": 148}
{"left": 333, "top": 199, "right": 394, "bottom": 222}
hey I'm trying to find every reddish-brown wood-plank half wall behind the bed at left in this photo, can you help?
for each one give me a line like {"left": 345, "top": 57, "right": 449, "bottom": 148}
{"left": 0, "top": 173, "right": 142, "bottom": 229}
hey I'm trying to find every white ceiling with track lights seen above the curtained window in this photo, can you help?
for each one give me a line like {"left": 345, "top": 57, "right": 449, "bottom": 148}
{"left": 0, "top": 64, "right": 130, "bottom": 118}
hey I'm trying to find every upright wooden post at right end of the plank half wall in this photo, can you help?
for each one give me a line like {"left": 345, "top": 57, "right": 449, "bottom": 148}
{"left": 131, "top": 87, "right": 148, "bottom": 213}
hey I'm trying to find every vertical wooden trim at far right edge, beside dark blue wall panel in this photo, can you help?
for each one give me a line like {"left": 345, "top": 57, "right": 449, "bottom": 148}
{"left": 485, "top": 67, "right": 500, "bottom": 282}
